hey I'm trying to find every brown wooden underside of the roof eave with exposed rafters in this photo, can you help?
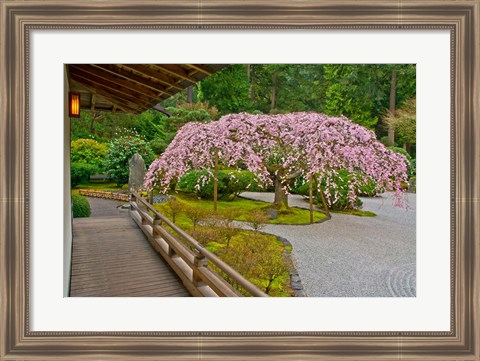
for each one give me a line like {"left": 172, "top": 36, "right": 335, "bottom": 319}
{"left": 67, "top": 64, "right": 228, "bottom": 114}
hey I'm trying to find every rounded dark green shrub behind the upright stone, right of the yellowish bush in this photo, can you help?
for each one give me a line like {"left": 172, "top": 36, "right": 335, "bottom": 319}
{"left": 105, "top": 135, "right": 155, "bottom": 185}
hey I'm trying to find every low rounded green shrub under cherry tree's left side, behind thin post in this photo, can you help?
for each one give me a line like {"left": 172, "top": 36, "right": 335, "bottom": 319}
{"left": 178, "top": 170, "right": 255, "bottom": 200}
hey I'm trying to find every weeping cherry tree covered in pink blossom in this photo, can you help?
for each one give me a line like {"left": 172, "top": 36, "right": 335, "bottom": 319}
{"left": 145, "top": 113, "right": 407, "bottom": 207}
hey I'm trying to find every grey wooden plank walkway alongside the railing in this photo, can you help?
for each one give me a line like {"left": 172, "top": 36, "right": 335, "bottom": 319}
{"left": 70, "top": 198, "right": 190, "bottom": 297}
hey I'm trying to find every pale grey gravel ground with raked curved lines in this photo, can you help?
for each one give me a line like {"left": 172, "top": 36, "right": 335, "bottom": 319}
{"left": 241, "top": 192, "right": 416, "bottom": 297}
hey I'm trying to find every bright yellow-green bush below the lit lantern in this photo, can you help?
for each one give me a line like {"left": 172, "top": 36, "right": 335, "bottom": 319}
{"left": 70, "top": 138, "right": 107, "bottom": 172}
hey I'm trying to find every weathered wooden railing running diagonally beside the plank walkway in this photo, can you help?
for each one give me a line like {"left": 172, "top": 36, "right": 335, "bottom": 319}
{"left": 130, "top": 192, "right": 268, "bottom": 297}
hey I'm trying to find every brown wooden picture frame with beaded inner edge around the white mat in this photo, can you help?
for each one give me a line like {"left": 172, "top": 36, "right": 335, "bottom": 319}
{"left": 0, "top": 0, "right": 480, "bottom": 361}
